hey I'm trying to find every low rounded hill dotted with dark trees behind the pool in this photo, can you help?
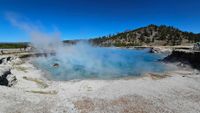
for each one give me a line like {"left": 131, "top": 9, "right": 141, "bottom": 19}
{"left": 90, "top": 25, "right": 200, "bottom": 47}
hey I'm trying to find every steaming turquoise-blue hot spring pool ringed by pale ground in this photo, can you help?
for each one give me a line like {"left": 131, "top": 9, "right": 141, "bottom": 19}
{"left": 33, "top": 47, "right": 170, "bottom": 80}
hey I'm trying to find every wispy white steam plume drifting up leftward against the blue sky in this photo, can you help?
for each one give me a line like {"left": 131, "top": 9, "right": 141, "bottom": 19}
{"left": 5, "top": 12, "right": 61, "bottom": 52}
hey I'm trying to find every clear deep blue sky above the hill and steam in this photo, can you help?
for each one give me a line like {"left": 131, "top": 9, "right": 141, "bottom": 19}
{"left": 0, "top": 0, "right": 200, "bottom": 42}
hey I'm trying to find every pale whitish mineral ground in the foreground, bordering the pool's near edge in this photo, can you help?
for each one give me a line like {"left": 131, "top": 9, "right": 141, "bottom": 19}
{"left": 0, "top": 49, "right": 200, "bottom": 113}
